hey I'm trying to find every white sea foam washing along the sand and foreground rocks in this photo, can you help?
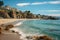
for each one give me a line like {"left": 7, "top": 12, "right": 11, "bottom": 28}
{"left": 10, "top": 21, "right": 46, "bottom": 40}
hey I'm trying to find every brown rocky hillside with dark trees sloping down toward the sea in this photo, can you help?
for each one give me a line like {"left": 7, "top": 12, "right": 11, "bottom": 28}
{"left": 0, "top": 1, "right": 59, "bottom": 20}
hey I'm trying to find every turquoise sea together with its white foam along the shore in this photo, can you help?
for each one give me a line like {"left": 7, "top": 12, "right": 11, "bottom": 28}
{"left": 9, "top": 20, "right": 60, "bottom": 40}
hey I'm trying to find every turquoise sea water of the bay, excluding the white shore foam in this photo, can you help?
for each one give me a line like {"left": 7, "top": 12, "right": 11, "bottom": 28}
{"left": 18, "top": 20, "right": 60, "bottom": 40}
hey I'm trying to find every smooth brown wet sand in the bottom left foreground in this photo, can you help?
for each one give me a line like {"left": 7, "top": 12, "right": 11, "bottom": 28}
{"left": 0, "top": 32, "right": 20, "bottom": 40}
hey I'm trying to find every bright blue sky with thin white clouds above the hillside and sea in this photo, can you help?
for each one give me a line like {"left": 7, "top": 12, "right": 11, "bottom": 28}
{"left": 3, "top": 0, "right": 60, "bottom": 16}
